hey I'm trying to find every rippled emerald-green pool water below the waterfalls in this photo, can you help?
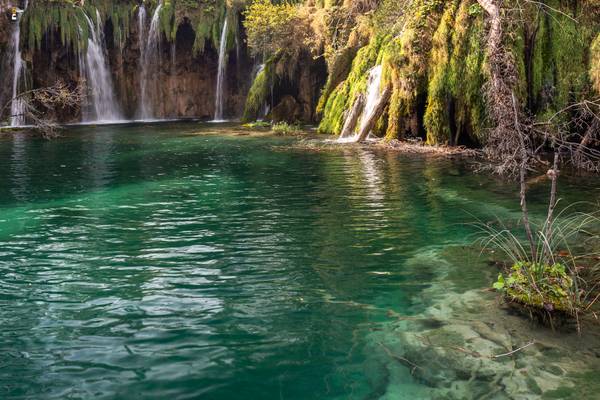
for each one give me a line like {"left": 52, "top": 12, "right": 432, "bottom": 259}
{"left": 0, "top": 123, "right": 600, "bottom": 399}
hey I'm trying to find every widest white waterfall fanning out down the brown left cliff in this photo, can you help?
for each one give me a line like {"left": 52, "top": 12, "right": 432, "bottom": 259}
{"left": 80, "top": 10, "right": 122, "bottom": 122}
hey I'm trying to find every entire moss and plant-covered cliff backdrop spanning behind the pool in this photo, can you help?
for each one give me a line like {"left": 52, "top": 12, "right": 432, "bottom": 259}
{"left": 0, "top": 0, "right": 600, "bottom": 146}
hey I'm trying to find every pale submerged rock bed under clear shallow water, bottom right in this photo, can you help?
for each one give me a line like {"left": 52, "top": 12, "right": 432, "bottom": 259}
{"left": 372, "top": 245, "right": 600, "bottom": 399}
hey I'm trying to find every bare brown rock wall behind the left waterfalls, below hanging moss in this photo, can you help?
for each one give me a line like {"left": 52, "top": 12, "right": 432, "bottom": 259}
{"left": 0, "top": 12, "right": 253, "bottom": 122}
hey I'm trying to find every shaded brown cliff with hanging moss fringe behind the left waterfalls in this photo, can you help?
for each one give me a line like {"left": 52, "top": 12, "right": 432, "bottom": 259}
{"left": 0, "top": 0, "right": 253, "bottom": 121}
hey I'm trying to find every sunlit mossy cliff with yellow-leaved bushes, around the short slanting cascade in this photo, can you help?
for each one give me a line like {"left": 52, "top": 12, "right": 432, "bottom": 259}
{"left": 240, "top": 0, "right": 600, "bottom": 145}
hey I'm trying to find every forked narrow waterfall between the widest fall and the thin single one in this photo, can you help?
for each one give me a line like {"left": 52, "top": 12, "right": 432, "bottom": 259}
{"left": 138, "top": 2, "right": 163, "bottom": 119}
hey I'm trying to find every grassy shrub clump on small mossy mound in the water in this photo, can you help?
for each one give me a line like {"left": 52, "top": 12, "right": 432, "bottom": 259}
{"left": 479, "top": 207, "right": 600, "bottom": 330}
